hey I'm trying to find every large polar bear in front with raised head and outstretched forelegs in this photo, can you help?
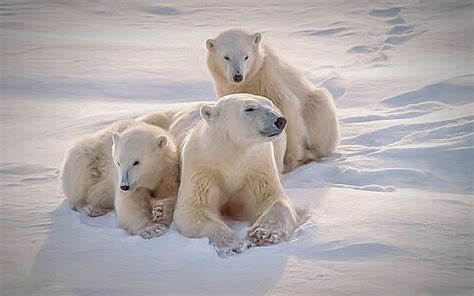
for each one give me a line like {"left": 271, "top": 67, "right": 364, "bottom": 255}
{"left": 174, "top": 94, "right": 297, "bottom": 255}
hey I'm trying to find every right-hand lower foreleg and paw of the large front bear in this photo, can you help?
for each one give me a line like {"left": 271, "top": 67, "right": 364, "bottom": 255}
{"left": 247, "top": 198, "right": 297, "bottom": 246}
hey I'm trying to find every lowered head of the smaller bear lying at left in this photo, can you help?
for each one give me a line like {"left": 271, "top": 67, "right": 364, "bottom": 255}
{"left": 112, "top": 125, "right": 170, "bottom": 191}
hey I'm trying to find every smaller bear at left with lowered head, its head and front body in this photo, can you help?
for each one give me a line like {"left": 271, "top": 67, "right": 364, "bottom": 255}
{"left": 112, "top": 123, "right": 180, "bottom": 238}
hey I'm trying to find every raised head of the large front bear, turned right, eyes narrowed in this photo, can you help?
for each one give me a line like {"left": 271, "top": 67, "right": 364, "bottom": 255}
{"left": 200, "top": 93, "right": 286, "bottom": 144}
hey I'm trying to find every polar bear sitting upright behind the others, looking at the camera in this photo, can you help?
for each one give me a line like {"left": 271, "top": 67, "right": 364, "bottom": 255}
{"left": 206, "top": 30, "right": 339, "bottom": 171}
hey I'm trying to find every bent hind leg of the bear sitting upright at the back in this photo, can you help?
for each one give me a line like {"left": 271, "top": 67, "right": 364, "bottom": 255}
{"left": 303, "top": 89, "right": 339, "bottom": 162}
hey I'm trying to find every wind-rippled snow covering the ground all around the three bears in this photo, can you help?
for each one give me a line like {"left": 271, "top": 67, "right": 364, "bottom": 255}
{"left": 0, "top": 0, "right": 474, "bottom": 295}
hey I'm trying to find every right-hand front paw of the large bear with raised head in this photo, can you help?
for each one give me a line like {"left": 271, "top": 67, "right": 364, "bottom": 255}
{"left": 247, "top": 221, "right": 288, "bottom": 247}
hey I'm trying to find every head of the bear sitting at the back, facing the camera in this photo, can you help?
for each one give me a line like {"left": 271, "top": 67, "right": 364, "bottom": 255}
{"left": 206, "top": 30, "right": 263, "bottom": 84}
